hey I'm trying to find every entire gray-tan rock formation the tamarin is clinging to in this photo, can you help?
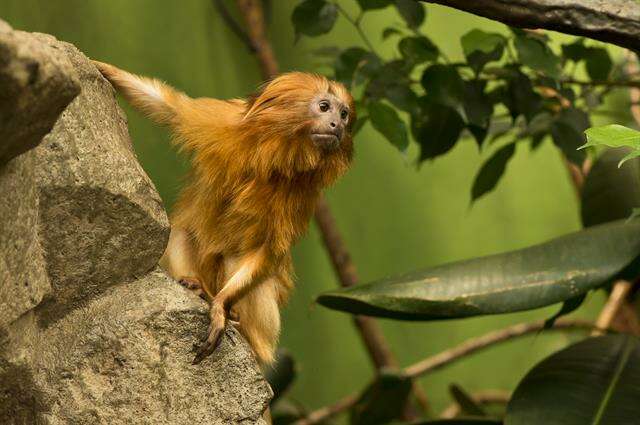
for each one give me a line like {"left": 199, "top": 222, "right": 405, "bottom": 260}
{"left": 0, "top": 21, "right": 271, "bottom": 425}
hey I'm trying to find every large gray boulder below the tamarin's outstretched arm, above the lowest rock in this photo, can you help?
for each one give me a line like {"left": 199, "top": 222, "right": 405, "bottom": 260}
{"left": 0, "top": 31, "right": 169, "bottom": 328}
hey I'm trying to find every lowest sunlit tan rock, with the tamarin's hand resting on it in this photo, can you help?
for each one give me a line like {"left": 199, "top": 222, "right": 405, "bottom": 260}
{"left": 0, "top": 271, "right": 271, "bottom": 425}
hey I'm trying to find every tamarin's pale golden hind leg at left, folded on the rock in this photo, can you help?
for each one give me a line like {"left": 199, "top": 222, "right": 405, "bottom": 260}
{"left": 160, "top": 227, "right": 211, "bottom": 301}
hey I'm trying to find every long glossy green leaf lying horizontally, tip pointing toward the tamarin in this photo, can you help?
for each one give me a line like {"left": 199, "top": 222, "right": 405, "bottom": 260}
{"left": 318, "top": 220, "right": 640, "bottom": 320}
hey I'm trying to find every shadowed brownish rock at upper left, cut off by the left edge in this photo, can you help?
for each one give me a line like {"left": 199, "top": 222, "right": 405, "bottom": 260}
{"left": 0, "top": 22, "right": 80, "bottom": 164}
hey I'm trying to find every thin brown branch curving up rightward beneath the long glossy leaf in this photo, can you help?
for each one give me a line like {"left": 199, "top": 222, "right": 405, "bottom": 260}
{"left": 294, "top": 320, "right": 594, "bottom": 425}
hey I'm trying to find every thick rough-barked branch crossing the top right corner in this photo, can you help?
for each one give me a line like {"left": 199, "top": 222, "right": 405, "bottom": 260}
{"left": 422, "top": 0, "right": 640, "bottom": 50}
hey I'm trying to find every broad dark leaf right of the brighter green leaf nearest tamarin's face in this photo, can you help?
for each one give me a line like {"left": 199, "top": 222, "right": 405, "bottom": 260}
{"left": 411, "top": 97, "right": 464, "bottom": 161}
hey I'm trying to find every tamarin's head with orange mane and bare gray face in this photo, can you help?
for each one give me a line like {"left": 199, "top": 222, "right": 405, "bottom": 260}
{"left": 242, "top": 72, "right": 356, "bottom": 180}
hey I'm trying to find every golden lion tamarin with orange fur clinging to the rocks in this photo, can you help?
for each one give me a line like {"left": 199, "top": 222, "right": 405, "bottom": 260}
{"left": 95, "top": 62, "right": 355, "bottom": 364}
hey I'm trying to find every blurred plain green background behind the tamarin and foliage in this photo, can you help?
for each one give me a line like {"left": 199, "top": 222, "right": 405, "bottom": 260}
{"left": 0, "top": 0, "right": 604, "bottom": 418}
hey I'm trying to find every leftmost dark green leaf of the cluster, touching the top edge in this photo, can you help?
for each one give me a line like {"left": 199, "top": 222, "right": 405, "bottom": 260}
{"left": 291, "top": 0, "right": 338, "bottom": 36}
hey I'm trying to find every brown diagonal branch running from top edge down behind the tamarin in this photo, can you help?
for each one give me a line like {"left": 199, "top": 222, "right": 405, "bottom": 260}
{"left": 218, "top": 0, "right": 428, "bottom": 410}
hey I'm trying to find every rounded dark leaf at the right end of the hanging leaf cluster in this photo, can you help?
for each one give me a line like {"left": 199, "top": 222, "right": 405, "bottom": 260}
{"left": 551, "top": 108, "right": 591, "bottom": 165}
